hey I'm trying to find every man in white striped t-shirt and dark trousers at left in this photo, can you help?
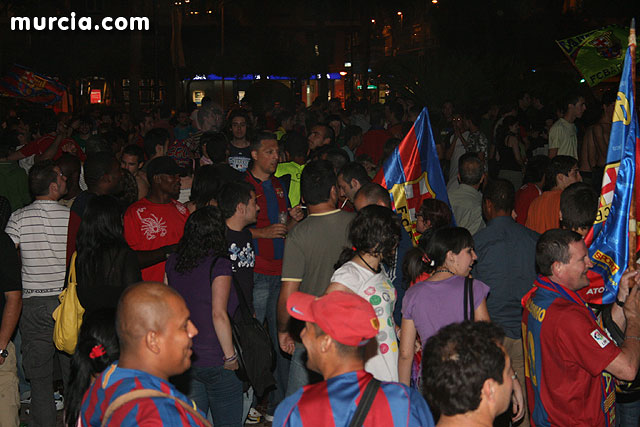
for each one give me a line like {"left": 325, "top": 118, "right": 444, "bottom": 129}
{"left": 5, "top": 160, "right": 69, "bottom": 426}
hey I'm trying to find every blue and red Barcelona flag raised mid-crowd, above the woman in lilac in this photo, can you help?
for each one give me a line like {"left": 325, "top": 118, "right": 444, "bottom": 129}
{"left": 373, "top": 107, "right": 449, "bottom": 241}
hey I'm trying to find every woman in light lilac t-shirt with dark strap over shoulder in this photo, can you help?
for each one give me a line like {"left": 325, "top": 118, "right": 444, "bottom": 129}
{"left": 398, "top": 227, "right": 489, "bottom": 385}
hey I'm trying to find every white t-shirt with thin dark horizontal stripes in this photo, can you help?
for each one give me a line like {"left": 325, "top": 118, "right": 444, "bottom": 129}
{"left": 5, "top": 200, "right": 70, "bottom": 298}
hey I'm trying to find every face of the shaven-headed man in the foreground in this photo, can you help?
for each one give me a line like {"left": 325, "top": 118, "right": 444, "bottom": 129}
{"left": 158, "top": 295, "right": 198, "bottom": 377}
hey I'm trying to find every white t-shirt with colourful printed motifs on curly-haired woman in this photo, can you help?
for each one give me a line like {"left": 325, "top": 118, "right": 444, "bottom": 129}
{"left": 331, "top": 261, "right": 398, "bottom": 381}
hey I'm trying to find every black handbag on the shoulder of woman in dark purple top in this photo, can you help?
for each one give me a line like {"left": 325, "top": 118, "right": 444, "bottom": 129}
{"left": 209, "top": 257, "right": 276, "bottom": 396}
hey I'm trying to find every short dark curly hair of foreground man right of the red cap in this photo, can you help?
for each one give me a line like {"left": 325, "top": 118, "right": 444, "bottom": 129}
{"left": 422, "top": 321, "right": 506, "bottom": 416}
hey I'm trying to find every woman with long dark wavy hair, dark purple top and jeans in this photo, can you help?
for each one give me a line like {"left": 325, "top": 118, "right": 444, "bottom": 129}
{"left": 165, "top": 206, "right": 242, "bottom": 427}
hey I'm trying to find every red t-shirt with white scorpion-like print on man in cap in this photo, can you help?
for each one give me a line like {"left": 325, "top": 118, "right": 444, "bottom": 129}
{"left": 124, "top": 198, "right": 189, "bottom": 282}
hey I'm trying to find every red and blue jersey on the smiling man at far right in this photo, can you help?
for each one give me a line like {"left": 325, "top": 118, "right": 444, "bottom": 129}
{"left": 522, "top": 276, "right": 620, "bottom": 427}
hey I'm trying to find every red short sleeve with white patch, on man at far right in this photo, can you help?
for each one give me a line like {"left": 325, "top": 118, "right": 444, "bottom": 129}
{"left": 554, "top": 306, "right": 620, "bottom": 376}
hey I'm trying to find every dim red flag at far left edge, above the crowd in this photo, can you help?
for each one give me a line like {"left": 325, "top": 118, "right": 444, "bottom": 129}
{"left": 0, "top": 65, "right": 65, "bottom": 105}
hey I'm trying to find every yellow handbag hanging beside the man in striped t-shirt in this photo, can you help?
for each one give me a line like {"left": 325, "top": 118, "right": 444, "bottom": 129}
{"left": 51, "top": 252, "right": 84, "bottom": 354}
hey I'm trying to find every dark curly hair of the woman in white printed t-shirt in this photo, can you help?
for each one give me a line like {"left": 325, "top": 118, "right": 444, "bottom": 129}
{"left": 335, "top": 205, "right": 402, "bottom": 270}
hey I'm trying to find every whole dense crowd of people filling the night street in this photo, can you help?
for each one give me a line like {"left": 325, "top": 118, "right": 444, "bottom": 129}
{"left": 0, "top": 88, "right": 640, "bottom": 427}
